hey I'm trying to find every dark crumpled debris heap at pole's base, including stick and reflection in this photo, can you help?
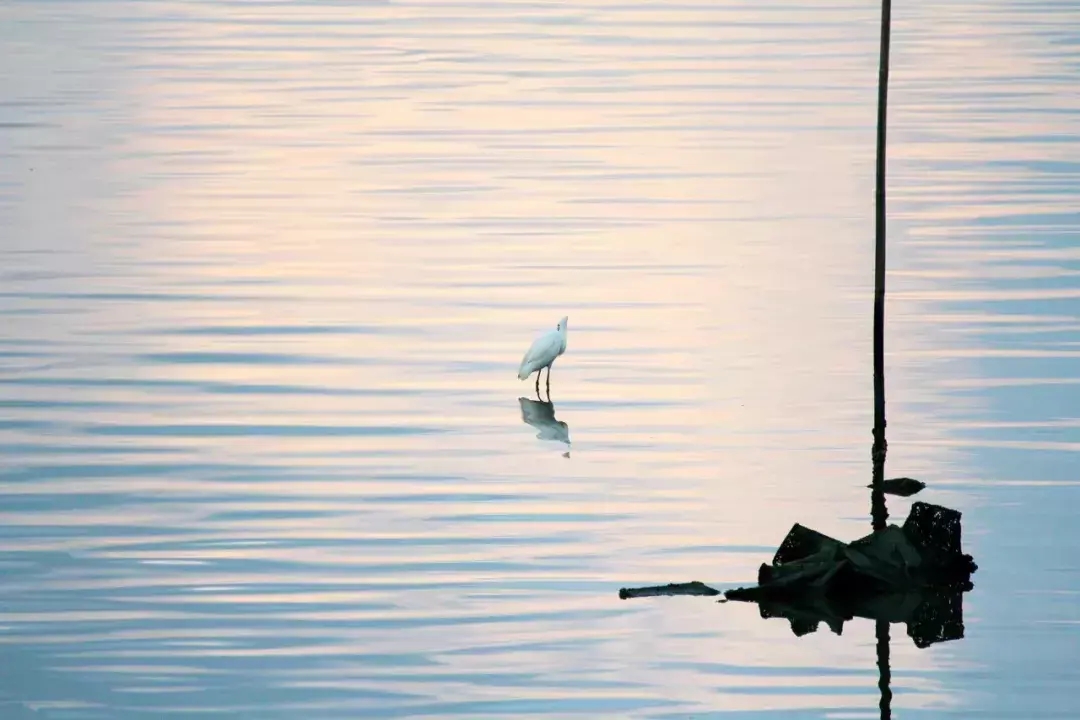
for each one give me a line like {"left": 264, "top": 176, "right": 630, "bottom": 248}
{"left": 619, "top": 502, "right": 977, "bottom": 648}
